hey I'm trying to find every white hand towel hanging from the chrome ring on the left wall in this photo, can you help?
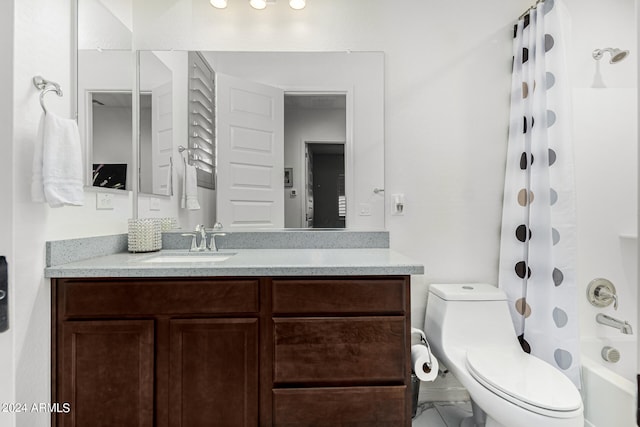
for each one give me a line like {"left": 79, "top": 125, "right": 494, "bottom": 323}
{"left": 31, "top": 113, "right": 84, "bottom": 207}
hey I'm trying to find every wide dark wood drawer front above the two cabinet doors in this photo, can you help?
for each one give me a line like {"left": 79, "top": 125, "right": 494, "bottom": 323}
{"left": 59, "top": 279, "right": 259, "bottom": 318}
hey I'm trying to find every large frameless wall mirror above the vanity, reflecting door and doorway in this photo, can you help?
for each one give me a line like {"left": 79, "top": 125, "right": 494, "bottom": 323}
{"left": 78, "top": 0, "right": 385, "bottom": 230}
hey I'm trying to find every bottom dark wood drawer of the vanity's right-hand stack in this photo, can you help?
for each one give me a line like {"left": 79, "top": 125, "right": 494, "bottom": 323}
{"left": 273, "top": 386, "right": 408, "bottom": 427}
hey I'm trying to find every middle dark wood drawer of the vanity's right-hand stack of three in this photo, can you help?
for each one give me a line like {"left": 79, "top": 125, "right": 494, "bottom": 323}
{"left": 273, "top": 316, "right": 408, "bottom": 384}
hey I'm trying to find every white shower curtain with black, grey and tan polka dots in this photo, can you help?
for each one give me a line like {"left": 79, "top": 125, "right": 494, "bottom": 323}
{"left": 499, "top": 0, "right": 580, "bottom": 387}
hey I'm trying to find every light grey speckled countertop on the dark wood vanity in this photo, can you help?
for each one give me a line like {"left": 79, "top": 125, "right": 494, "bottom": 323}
{"left": 45, "top": 248, "right": 424, "bottom": 278}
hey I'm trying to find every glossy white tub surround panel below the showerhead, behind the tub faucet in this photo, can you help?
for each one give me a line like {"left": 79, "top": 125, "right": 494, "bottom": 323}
{"left": 573, "top": 88, "right": 638, "bottom": 338}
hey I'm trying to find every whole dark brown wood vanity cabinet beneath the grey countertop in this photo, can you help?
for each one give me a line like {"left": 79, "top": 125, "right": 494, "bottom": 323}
{"left": 52, "top": 276, "right": 411, "bottom": 427}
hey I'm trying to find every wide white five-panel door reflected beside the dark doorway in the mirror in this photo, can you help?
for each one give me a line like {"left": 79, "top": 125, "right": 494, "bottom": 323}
{"left": 216, "top": 73, "right": 284, "bottom": 229}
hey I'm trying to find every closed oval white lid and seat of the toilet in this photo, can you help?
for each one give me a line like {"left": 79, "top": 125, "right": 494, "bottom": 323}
{"left": 467, "top": 348, "right": 582, "bottom": 412}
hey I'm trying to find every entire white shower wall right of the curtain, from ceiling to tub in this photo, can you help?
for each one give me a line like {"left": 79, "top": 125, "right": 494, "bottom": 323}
{"left": 565, "top": 0, "right": 639, "bottom": 344}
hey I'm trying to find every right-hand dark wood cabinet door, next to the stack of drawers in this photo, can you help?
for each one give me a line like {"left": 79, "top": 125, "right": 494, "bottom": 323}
{"left": 169, "top": 319, "right": 258, "bottom": 427}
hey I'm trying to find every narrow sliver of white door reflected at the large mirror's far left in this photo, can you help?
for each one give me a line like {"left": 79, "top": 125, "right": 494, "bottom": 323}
{"left": 151, "top": 82, "right": 173, "bottom": 196}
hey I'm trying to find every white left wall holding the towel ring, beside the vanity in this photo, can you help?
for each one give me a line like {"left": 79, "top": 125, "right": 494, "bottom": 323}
{"left": 11, "top": 0, "right": 73, "bottom": 426}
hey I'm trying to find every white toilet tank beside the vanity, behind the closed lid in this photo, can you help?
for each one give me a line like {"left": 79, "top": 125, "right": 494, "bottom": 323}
{"left": 424, "top": 283, "right": 520, "bottom": 357}
